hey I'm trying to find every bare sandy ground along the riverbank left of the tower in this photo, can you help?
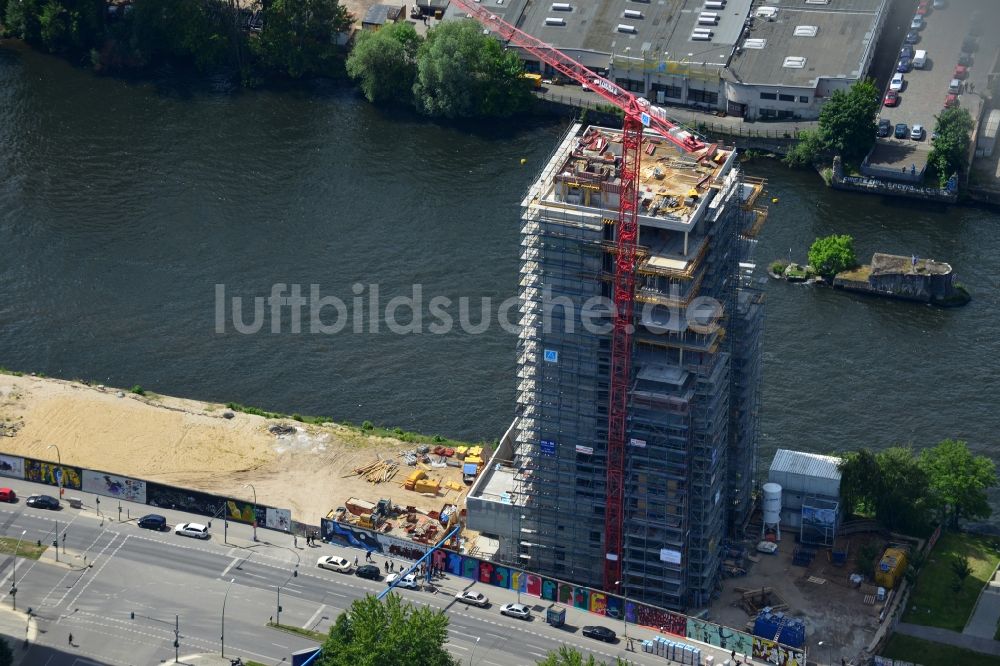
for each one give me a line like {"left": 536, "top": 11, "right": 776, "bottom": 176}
{"left": 0, "top": 375, "right": 467, "bottom": 525}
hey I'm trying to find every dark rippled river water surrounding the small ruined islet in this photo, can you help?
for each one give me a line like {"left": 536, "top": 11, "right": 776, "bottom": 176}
{"left": 0, "top": 44, "right": 1000, "bottom": 520}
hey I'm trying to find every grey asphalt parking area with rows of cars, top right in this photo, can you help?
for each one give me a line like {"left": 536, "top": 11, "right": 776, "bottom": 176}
{"left": 869, "top": 0, "right": 1000, "bottom": 174}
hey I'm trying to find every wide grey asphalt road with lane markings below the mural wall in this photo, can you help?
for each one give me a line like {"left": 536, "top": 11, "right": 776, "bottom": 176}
{"left": 0, "top": 480, "right": 744, "bottom": 666}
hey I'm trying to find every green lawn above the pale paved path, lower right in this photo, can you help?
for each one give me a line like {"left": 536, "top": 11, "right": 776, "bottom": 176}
{"left": 903, "top": 532, "right": 1000, "bottom": 628}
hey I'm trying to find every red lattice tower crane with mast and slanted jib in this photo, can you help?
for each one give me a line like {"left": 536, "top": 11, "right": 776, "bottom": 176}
{"left": 451, "top": 0, "right": 705, "bottom": 592}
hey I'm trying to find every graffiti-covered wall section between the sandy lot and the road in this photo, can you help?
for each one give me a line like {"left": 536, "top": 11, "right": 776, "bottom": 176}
{"left": 0, "top": 453, "right": 292, "bottom": 532}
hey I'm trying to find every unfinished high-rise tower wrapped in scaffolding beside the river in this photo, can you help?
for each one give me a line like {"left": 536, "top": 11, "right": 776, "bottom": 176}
{"left": 468, "top": 124, "right": 766, "bottom": 609}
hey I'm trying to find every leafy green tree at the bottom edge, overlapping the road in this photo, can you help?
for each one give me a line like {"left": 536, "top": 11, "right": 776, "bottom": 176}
{"left": 317, "top": 594, "right": 459, "bottom": 666}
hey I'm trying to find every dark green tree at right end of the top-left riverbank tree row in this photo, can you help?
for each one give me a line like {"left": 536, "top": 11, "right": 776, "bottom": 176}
{"left": 256, "top": 0, "right": 354, "bottom": 79}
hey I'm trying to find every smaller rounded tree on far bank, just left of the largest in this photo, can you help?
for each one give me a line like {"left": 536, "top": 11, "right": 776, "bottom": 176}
{"left": 347, "top": 23, "right": 423, "bottom": 104}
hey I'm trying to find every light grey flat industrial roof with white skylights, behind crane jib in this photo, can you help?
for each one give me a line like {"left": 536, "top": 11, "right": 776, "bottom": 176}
{"left": 516, "top": 0, "right": 752, "bottom": 64}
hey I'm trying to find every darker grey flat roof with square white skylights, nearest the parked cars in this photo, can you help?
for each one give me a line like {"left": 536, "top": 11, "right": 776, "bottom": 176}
{"left": 729, "top": 0, "right": 886, "bottom": 87}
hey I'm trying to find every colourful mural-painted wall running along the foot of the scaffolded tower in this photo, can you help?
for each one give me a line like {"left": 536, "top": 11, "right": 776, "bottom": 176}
{"left": 320, "top": 518, "right": 806, "bottom": 664}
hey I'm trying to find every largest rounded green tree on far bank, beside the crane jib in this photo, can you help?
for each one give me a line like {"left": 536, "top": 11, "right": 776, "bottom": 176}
{"left": 413, "top": 20, "right": 532, "bottom": 118}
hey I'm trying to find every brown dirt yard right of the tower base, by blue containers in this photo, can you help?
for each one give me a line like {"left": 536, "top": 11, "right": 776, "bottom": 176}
{"left": 710, "top": 534, "right": 880, "bottom": 664}
